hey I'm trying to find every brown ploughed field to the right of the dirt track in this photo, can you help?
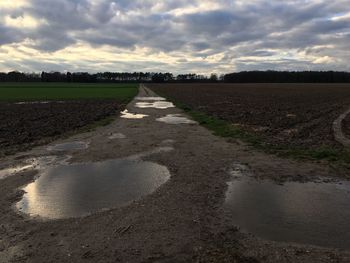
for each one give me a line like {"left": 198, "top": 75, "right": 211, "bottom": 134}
{"left": 150, "top": 84, "right": 350, "bottom": 162}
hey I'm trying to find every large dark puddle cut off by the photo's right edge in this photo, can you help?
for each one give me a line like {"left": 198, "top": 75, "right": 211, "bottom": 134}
{"left": 225, "top": 167, "right": 350, "bottom": 249}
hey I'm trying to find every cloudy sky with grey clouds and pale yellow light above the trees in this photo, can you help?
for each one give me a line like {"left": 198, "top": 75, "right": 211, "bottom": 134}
{"left": 0, "top": 0, "right": 350, "bottom": 74}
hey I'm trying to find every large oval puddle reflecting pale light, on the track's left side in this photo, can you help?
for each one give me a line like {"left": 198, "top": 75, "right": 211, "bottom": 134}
{"left": 16, "top": 159, "right": 170, "bottom": 219}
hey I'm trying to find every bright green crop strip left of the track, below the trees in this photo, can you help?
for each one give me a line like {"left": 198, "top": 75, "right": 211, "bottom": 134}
{"left": 0, "top": 83, "right": 137, "bottom": 101}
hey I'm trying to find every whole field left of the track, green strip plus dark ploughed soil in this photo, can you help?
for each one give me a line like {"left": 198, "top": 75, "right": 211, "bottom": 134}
{"left": 0, "top": 83, "right": 138, "bottom": 155}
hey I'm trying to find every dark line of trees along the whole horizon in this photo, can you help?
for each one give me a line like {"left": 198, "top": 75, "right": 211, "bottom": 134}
{"left": 0, "top": 71, "right": 350, "bottom": 83}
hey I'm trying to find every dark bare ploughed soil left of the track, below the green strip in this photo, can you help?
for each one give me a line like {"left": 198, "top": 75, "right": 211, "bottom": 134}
{"left": 0, "top": 100, "right": 125, "bottom": 155}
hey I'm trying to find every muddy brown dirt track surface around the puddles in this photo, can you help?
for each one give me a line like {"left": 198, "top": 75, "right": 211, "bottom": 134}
{"left": 0, "top": 87, "right": 350, "bottom": 262}
